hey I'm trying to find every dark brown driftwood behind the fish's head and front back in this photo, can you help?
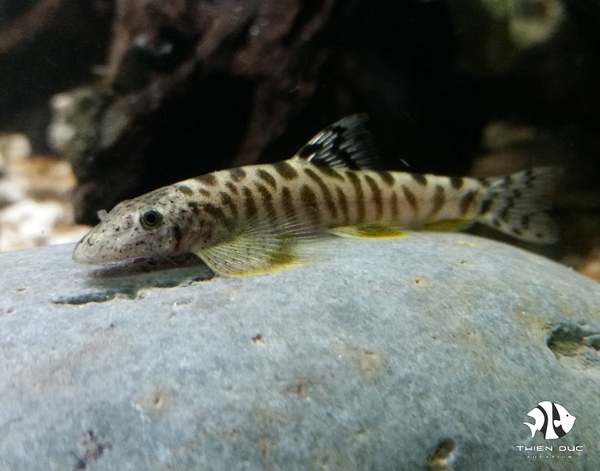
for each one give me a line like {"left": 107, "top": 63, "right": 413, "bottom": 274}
{"left": 58, "top": 0, "right": 354, "bottom": 223}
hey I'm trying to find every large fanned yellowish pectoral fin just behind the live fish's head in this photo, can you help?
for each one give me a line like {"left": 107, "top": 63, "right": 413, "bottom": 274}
{"left": 194, "top": 210, "right": 323, "bottom": 277}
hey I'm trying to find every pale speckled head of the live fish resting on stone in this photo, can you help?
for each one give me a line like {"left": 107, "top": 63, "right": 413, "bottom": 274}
{"left": 73, "top": 192, "right": 193, "bottom": 265}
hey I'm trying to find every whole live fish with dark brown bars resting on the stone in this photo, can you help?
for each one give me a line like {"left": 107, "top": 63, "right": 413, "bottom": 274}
{"left": 73, "top": 114, "right": 560, "bottom": 277}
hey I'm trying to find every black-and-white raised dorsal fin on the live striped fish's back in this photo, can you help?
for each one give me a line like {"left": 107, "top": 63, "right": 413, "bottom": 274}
{"left": 294, "top": 114, "right": 381, "bottom": 170}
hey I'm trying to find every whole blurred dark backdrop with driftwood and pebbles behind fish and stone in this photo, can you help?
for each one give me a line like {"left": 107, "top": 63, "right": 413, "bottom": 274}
{"left": 0, "top": 0, "right": 600, "bottom": 281}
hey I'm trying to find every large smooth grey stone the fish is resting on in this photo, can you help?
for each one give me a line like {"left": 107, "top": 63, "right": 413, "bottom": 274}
{"left": 0, "top": 234, "right": 600, "bottom": 471}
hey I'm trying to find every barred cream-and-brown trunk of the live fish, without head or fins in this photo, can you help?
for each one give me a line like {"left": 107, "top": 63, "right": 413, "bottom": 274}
{"left": 179, "top": 162, "right": 485, "bottom": 232}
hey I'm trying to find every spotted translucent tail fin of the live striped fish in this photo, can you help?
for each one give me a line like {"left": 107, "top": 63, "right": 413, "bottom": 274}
{"left": 477, "top": 167, "right": 562, "bottom": 244}
